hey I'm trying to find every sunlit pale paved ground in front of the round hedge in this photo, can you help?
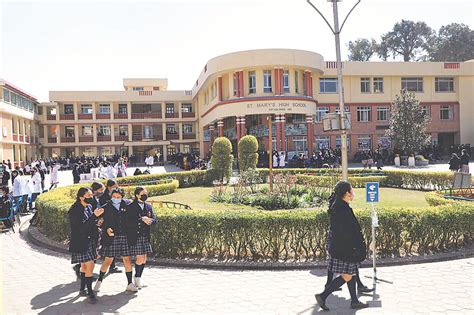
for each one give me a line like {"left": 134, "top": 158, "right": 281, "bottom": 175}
{"left": 0, "top": 226, "right": 474, "bottom": 315}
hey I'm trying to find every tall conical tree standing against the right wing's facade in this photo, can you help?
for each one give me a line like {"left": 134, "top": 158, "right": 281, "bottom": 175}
{"left": 386, "top": 89, "right": 430, "bottom": 154}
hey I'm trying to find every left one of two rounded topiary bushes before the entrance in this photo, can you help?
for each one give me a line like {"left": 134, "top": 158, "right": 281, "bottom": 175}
{"left": 211, "top": 137, "right": 234, "bottom": 182}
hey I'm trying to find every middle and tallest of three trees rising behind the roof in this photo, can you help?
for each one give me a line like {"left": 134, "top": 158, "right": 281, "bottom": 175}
{"left": 377, "top": 20, "right": 433, "bottom": 61}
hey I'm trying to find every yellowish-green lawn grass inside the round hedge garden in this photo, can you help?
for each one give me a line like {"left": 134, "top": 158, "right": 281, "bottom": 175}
{"left": 150, "top": 187, "right": 428, "bottom": 210}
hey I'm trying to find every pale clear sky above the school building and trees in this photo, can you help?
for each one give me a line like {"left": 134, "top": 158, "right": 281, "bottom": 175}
{"left": 0, "top": 0, "right": 474, "bottom": 102}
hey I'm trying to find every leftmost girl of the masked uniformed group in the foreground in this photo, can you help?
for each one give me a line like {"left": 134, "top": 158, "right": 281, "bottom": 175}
{"left": 68, "top": 187, "right": 104, "bottom": 304}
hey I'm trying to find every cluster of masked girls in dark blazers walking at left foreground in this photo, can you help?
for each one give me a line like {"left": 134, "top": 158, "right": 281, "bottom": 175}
{"left": 68, "top": 180, "right": 156, "bottom": 303}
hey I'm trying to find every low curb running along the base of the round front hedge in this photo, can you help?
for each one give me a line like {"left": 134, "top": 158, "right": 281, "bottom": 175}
{"left": 26, "top": 225, "right": 474, "bottom": 271}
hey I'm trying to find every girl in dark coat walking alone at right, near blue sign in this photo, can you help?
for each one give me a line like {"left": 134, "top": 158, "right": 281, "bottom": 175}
{"left": 315, "top": 181, "right": 368, "bottom": 311}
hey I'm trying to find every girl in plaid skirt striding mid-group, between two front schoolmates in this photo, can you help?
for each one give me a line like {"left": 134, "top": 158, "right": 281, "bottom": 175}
{"left": 94, "top": 188, "right": 138, "bottom": 292}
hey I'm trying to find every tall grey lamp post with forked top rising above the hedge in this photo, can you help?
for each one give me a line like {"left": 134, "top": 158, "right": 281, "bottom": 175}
{"left": 306, "top": 0, "right": 361, "bottom": 181}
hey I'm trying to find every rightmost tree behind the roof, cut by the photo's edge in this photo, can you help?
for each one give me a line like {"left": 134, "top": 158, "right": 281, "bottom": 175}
{"left": 428, "top": 23, "right": 474, "bottom": 61}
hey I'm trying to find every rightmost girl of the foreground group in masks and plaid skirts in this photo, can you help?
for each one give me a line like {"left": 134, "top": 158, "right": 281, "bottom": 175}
{"left": 126, "top": 187, "right": 156, "bottom": 288}
